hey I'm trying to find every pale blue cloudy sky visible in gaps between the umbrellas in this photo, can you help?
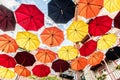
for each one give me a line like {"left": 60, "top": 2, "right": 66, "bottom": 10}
{"left": 0, "top": 0, "right": 120, "bottom": 79}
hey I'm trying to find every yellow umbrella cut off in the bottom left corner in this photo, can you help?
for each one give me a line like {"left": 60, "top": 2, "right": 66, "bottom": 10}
{"left": 0, "top": 68, "right": 15, "bottom": 79}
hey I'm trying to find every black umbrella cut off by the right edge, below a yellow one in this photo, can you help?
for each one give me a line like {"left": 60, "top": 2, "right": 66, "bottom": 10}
{"left": 105, "top": 46, "right": 120, "bottom": 60}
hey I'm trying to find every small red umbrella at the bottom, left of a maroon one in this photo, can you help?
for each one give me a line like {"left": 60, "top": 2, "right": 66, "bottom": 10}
{"left": 32, "top": 64, "right": 50, "bottom": 77}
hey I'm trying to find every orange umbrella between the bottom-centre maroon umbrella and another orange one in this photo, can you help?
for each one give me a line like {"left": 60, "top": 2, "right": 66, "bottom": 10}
{"left": 71, "top": 57, "right": 88, "bottom": 70}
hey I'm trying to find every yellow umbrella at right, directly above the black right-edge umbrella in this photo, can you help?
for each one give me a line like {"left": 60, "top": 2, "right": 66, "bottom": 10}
{"left": 97, "top": 34, "right": 117, "bottom": 50}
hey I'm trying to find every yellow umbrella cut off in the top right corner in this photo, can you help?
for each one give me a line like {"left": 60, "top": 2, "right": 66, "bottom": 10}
{"left": 104, "top": 0, "right": 120, "bottom": 12}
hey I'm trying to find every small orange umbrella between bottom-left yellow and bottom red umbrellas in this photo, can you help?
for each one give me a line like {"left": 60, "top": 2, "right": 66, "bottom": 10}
{"left": 14, "top": 65, "right": 31, "bottom": 77}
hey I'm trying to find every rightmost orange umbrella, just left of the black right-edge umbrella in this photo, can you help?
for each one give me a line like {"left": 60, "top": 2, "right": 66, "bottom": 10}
{"left": 88, "top": 51, "right": 104, "bottom": 66}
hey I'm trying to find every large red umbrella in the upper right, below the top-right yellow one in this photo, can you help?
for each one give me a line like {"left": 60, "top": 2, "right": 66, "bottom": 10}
{"left": 89, "top": 15, "right": 112, "bottom": 36}
